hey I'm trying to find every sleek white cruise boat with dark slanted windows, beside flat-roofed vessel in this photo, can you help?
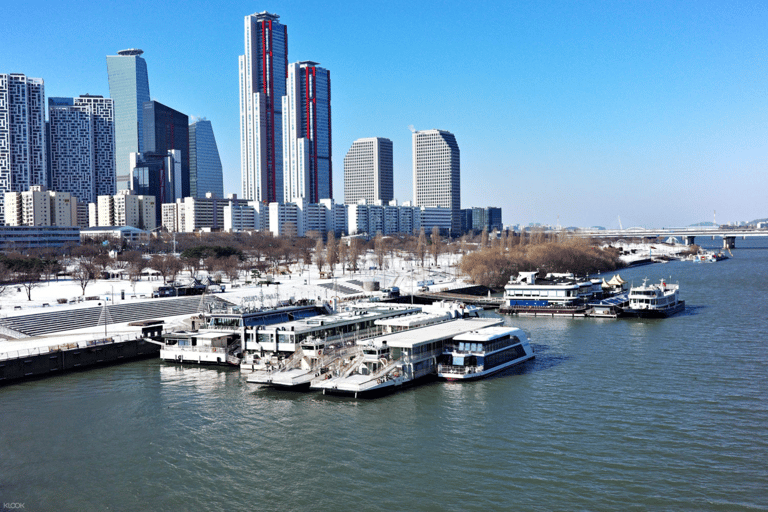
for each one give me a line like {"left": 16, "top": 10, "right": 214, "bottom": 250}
{"left": 437, "top": 326, "right": 535, "bottom": 380}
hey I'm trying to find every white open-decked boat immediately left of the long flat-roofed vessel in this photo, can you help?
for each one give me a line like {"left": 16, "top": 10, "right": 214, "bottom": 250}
{"left": 246, "top": 338, "right": 362, "bottom": 391}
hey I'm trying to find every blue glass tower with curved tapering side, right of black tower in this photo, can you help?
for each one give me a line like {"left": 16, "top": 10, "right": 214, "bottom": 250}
{"left": 189, "top": 119, "right": 224, "bottom": 197}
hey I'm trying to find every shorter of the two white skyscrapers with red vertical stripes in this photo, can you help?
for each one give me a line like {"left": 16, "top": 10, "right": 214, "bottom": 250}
{"left": 282, "top": 61, "right": 333, "bottom": 203}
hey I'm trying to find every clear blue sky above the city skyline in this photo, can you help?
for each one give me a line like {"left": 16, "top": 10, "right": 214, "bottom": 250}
{"left": 0, "top": 0, "right": 768, "bottom": 228}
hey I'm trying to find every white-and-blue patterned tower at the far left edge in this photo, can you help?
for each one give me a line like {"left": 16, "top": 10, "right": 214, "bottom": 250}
{"left": 0, "top": 73, "right": 48, "bottom": 220}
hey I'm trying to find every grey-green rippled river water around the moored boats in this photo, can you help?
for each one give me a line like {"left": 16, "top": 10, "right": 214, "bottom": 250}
{"left": 0, "top": 239, "right": 768, "bottom": 511}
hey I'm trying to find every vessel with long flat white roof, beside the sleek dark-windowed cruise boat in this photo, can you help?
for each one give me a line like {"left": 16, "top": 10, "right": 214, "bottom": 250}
{"left": 310, "top": 318, "right": 502, "bottom": 398}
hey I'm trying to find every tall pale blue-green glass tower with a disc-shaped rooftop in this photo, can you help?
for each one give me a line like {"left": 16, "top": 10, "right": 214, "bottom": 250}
{"left": 107, "top": 48, "right": 149, "bottom": 190}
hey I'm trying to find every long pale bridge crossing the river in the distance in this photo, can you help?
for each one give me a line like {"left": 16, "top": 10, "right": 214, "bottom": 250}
{"left": 569, "top": 227, "right": 768, "bottom": 249}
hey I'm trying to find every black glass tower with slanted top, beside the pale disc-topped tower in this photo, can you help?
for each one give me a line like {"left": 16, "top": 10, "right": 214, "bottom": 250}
{"left": 143, "top": 101, "right": 190, "bottom": 198}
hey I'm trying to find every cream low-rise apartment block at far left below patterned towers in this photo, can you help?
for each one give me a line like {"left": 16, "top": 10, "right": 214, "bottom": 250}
{"left": 4, "top": 185, "right": 79, "bottom": 226}
